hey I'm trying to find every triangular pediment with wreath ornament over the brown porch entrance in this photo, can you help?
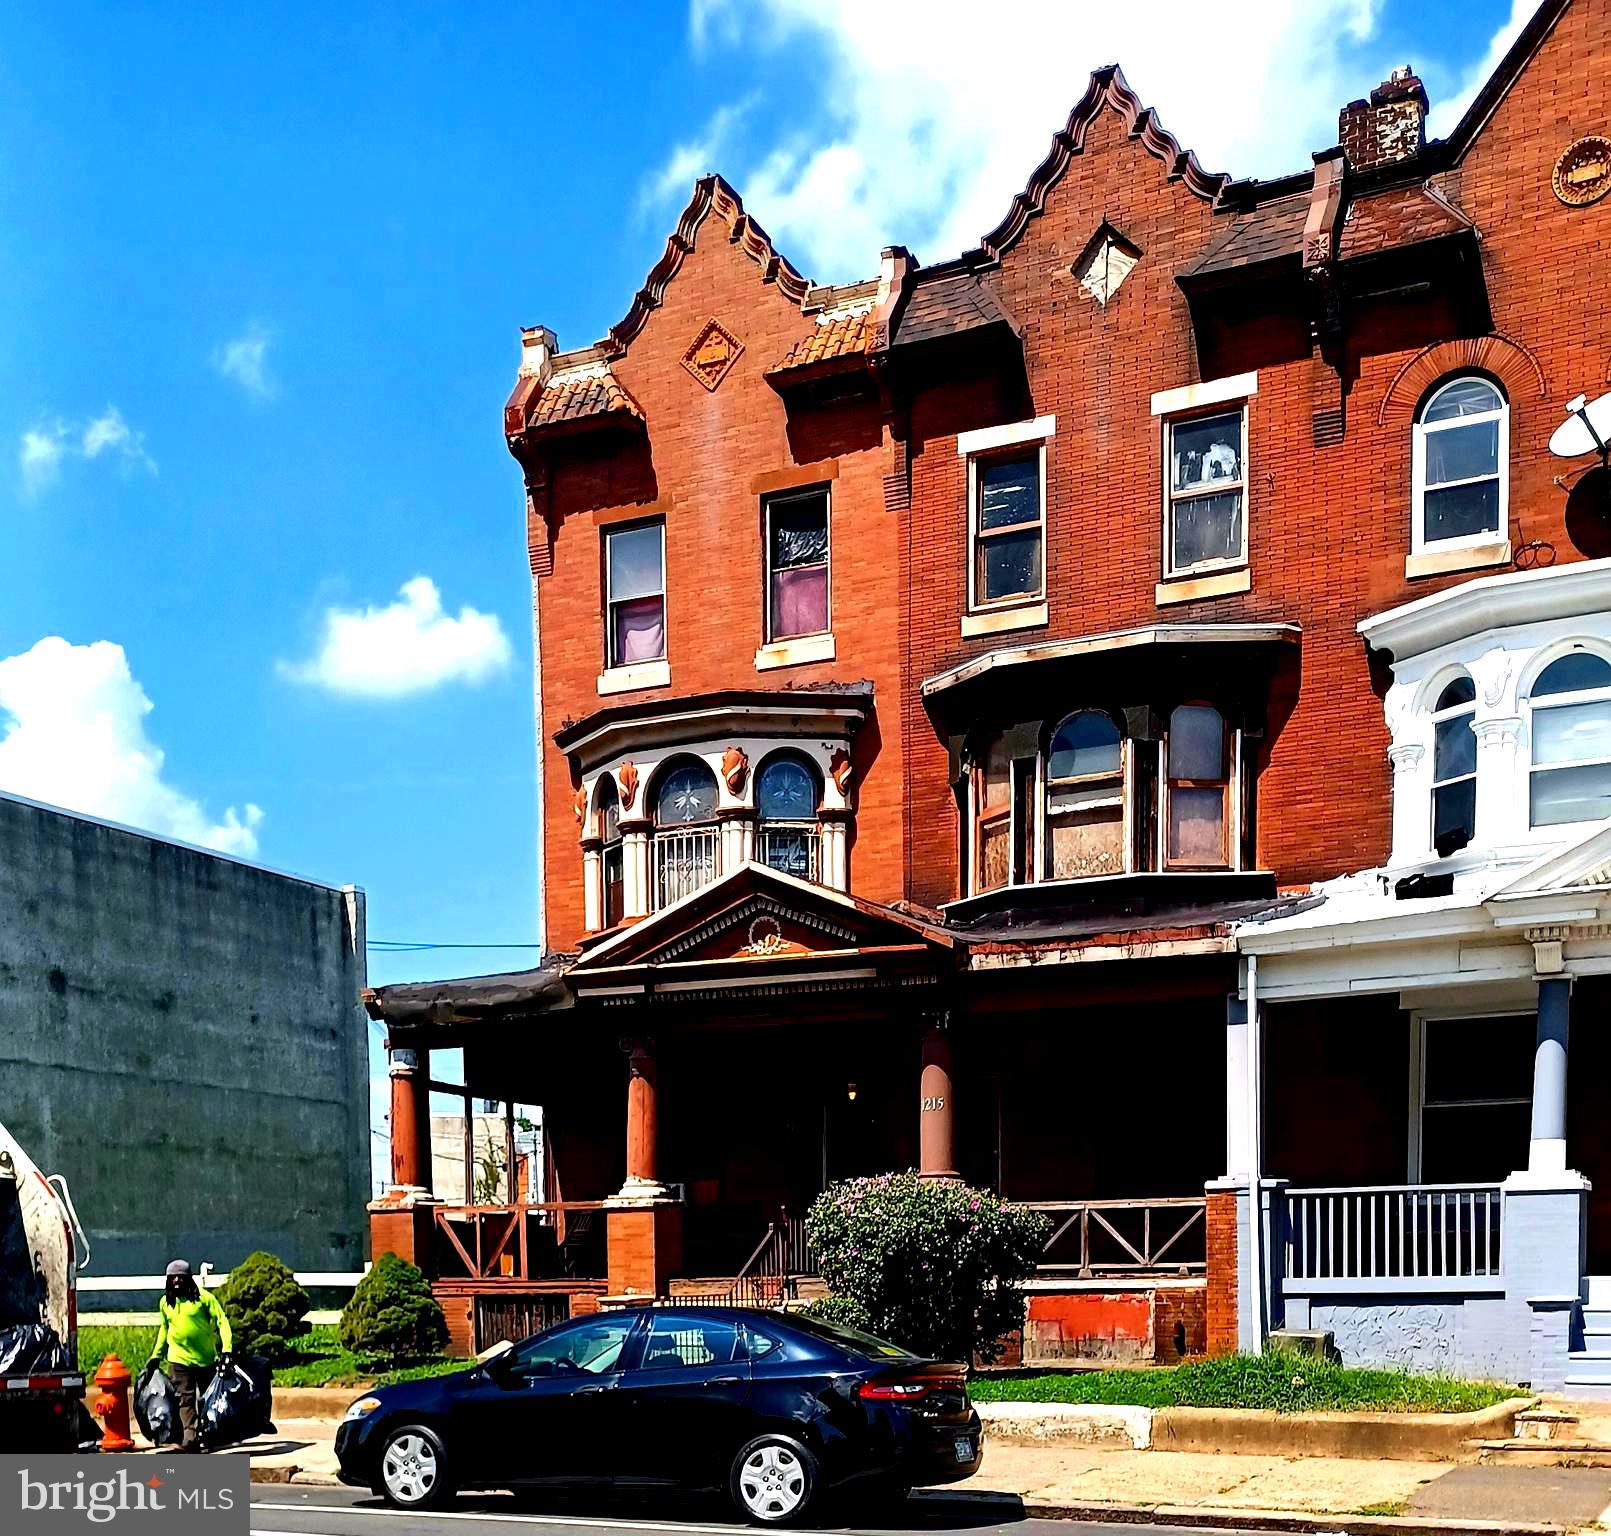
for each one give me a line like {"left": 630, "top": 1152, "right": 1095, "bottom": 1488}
{"left": 567, "top": 864, "right": 962, "bottom": 996}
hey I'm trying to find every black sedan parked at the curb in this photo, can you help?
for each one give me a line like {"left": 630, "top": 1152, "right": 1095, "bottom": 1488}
{"left": 335, "top": 1307, "right": 981, "bottom": 1525}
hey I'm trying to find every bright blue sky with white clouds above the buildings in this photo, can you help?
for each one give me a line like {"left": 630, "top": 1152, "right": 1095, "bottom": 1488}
{"left": 0, "top": 0, "right": 1530, "bottom": 1166}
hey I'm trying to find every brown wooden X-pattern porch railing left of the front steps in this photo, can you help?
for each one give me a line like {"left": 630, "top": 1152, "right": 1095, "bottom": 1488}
{"left": 435, "top": 1201, "right": 604, "bottom": 1280}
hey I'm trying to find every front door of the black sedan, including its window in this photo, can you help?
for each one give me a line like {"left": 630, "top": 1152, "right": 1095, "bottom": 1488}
{"left": 449, "top": 1312, "right": 638, "bottom": 1488}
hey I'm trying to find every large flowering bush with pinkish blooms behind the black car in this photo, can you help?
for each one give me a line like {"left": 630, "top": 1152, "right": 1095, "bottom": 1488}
{"left": 806, "top": 1173, "right": 1050, "bottom": 1362}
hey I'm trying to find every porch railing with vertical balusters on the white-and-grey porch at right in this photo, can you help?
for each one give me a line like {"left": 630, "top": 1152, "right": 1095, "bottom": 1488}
{"left": 1286, "top": 1185, "right": 1505, "bottom": 1281}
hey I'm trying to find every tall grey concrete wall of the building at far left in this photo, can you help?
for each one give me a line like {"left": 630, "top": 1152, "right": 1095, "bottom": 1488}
{"left": 0, "top": 795, "right": 369, "bottom": 1275}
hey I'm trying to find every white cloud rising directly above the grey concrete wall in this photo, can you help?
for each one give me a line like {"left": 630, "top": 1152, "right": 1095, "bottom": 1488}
{"left": 0, "top": 635, "right": 263, "bottom": 857}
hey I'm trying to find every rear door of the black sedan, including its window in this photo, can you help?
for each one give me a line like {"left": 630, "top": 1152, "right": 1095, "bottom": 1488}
{"left": 614, "top": 1309, "right": 749, "bottom": 1486}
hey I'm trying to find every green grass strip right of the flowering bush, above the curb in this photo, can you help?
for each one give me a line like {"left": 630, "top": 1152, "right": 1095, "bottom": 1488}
{"left": 968, "top": 1354, "right": 1516, "bottom": 1414}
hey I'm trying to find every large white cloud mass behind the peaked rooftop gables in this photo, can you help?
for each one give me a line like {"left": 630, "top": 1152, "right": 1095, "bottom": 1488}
{"left": 676, "top": 0, "right": 1385, "bottom": 280}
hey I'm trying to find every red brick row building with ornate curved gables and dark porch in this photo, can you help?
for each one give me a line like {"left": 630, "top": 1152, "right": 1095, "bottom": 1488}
{"left": 374, "top": 0, "right": 1611, "bottom": 1359}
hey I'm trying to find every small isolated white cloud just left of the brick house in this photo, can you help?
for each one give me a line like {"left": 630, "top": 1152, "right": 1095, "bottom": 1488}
{"left": 280, "top": 575, "right": 512, "bottom": 698}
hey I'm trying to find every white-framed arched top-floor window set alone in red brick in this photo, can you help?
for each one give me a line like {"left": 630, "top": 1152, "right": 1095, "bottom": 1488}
{"left": 1411, "top": 374, "right": 1510, "bottom": 553}
